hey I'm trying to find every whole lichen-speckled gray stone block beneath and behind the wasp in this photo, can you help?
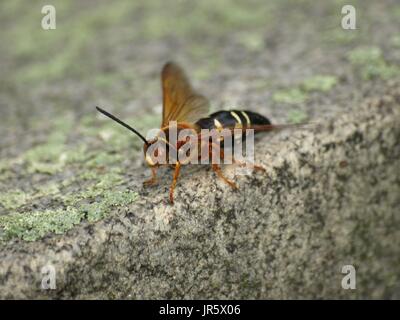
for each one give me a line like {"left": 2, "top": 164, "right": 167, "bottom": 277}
{"left": 0, "top": 0, "right": 400, "bottom": 299}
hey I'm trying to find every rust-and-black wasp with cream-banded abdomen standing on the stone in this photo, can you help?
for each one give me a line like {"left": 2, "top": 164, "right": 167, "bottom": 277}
{"left": 96, "top": 62, "right": 304, "bottom": 203}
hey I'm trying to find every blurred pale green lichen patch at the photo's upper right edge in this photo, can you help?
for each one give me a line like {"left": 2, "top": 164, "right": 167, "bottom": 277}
{"left": 348, "top": 47, "right": 400, "bottom": 80}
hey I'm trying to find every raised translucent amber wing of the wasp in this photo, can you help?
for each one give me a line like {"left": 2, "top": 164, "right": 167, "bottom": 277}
{"left": 161, "top": 62, "right": 210, "bottom": 127}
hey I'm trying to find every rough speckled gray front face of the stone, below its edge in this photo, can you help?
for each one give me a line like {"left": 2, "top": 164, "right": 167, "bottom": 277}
{"left": 0, "top": 85, "right": 400, "bottom": 299}
